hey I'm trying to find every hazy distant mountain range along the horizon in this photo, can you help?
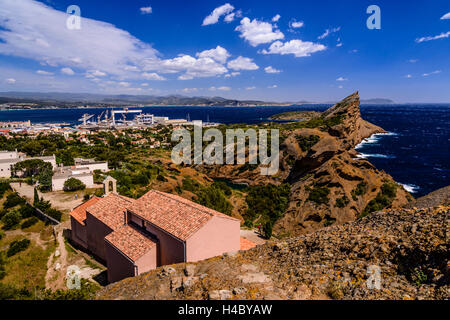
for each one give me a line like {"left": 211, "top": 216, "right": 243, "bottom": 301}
{"left": 0, "top": 92, "right": 394, "bottom": 107}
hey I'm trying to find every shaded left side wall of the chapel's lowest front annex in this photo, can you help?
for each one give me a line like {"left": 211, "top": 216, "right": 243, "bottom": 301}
{"left": 104, "top": 240, "right": 136, "bottom": 283}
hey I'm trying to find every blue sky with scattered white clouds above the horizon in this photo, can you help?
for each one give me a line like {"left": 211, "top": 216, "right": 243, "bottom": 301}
{"left": 0, "top": 0, "right": 450, "bottom": 102}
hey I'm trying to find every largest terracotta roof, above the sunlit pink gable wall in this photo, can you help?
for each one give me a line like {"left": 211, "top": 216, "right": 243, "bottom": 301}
{"left": 127, "top": 190, "right": 239, "bottom": 241}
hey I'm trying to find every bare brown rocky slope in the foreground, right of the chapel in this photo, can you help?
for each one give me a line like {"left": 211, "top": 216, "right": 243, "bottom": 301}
{"left": 98, "top": 207, "right": 450, "bottom": 300}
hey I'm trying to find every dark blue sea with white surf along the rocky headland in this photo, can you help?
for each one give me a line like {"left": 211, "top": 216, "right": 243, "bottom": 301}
{"left": 0, "top": 104, "right": 450, "bottom": 197}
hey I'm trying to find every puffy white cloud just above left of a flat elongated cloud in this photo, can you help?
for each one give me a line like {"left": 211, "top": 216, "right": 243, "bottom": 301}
{"left": 235, "top": 17, "right": 284, "bottom": 47}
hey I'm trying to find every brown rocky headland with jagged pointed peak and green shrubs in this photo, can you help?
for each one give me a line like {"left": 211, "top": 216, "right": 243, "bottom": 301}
{"left": 196, "top": 92, "right": 412, "bottom": 236}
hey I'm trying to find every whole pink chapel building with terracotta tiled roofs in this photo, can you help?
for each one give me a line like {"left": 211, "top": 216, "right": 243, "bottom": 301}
{"left": 70, "top": 190, "right": 244, "bottom": 282}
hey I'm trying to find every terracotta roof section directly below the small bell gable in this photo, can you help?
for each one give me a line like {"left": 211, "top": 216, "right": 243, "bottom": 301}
{"left": 86, "top": 193, "right": 134, "bottom": 230}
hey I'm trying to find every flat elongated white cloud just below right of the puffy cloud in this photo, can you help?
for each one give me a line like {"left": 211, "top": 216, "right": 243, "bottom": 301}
{"left": 261, "top": 40, "right": 327, "bottom": 58}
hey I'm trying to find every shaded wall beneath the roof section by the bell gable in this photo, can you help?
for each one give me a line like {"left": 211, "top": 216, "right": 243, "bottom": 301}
{"left": 85, "top": 212, "right": 113, "bottom": 261}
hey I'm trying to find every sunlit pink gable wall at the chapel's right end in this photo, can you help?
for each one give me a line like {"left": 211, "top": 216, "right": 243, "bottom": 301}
{"left": 186, "top": 216, "right": 240, "bottom": 262}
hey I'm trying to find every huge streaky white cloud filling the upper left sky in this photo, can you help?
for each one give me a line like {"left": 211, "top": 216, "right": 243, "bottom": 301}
{"left": 0, "top": 0, "right": 158, "bottom": 75}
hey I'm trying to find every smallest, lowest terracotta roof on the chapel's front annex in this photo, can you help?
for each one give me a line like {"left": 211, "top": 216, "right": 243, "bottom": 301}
{"left": 105, "top": 225, "right": 156, "bottom": 261}
